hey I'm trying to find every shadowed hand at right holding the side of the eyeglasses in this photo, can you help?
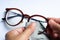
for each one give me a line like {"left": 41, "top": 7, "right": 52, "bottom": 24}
{"left": 48, "top": 18, "right": 60, "bottom": 40}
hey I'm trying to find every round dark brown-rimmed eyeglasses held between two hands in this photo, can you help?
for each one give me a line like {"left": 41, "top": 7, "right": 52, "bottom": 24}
{"left": 2, "top": 8, "right": 53, "bottom": 38}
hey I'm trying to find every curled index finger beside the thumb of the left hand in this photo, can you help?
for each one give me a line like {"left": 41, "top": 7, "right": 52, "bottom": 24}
{"left": 6, "top": 28, "right": 24, "bottom": 38}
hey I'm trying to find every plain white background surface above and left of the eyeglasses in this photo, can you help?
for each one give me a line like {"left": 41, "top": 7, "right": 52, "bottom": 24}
{"left": 0, "top": 0, "right": 60, "bottom": 40}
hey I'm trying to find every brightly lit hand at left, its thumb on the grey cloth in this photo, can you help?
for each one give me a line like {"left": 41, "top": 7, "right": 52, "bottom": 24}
{"left": 5, "top": 23, "right": 36, "bottom": 40}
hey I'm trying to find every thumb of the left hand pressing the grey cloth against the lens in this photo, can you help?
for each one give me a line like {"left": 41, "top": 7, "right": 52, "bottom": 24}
{"left": 19, "top": 23, "right": 36, "bottom": 38}
